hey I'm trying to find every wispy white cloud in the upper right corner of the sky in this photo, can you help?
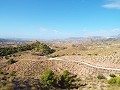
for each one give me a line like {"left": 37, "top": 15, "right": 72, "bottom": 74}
{"left": 102, "top": 0, "right": 120, "bottom": 9}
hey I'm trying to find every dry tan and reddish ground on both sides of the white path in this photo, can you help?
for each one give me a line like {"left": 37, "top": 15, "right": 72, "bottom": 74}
{"left": 0, "top": 42, "right": 120, "bottom": 90}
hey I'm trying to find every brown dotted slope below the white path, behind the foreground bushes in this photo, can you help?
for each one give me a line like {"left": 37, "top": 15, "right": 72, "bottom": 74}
{"left": 4, "top": 60, "right": 120, "bottom": 78}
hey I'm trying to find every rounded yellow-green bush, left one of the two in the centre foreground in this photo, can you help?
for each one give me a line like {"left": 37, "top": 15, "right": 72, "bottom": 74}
{"left": 40, "top": 69, "right": 57, "bottom": 86}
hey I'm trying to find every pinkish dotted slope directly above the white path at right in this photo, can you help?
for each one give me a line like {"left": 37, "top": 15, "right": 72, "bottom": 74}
{"left": 58, "top": 54, "right": 120, "bottom": 68}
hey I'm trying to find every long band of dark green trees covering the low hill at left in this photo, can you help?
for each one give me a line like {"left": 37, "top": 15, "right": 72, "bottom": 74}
{"left": 0, "top": 42, "right": 55, "bottom": 56}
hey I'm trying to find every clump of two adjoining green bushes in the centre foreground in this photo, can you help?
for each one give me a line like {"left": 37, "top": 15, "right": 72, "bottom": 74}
{"left": 40, "top": 69, "right": 78, "bottom": 89}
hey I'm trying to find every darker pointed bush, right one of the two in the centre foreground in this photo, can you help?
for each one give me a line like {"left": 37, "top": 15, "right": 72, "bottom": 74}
{"left": 58, "top": 70, "right": 72, "bottom": 88}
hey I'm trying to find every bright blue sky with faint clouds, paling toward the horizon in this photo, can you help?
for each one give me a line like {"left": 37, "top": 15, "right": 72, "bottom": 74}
{"left": 0, "top": 0, "right": 120, "bottom": 39}
